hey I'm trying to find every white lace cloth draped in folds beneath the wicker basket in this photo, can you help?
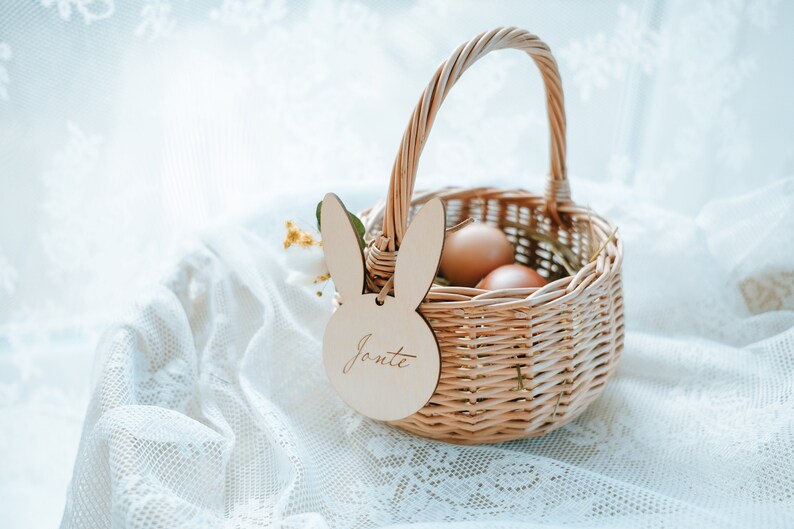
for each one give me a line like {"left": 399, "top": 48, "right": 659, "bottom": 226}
{"left": 62, "top": 179, "right": 794, "bottom": 529}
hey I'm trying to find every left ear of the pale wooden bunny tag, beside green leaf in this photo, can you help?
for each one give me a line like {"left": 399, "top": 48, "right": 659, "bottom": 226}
{"left": 320, "top": 193, "right": 364, "bottom": 299}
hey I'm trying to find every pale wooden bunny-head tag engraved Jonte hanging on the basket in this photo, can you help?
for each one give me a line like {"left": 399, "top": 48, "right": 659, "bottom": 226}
{"left": 321, "top": 193, "right": 445, "bottom": 421}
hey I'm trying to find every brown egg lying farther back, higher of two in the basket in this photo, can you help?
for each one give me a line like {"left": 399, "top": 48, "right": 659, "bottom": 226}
{"left": 440, "top": 222, "right": 515, "bottom": 287}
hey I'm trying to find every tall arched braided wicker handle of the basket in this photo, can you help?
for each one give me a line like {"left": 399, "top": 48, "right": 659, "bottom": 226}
{"left": 383, "top": 28, "right": 571, "bottom": 251}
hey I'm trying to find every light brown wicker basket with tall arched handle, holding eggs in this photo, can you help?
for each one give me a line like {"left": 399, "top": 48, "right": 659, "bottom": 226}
{"left": 356, "top": 28, "right": 624, "bottom": 444}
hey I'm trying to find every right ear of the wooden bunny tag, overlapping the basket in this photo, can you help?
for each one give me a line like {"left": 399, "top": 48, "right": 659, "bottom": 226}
{"left": 394, "top": 198, "right": 446, "bottom": 308}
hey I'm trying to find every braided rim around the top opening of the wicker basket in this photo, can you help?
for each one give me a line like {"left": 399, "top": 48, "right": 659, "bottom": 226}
{"left": 360, "top": 187, "right": 623, "bottom": 316}
